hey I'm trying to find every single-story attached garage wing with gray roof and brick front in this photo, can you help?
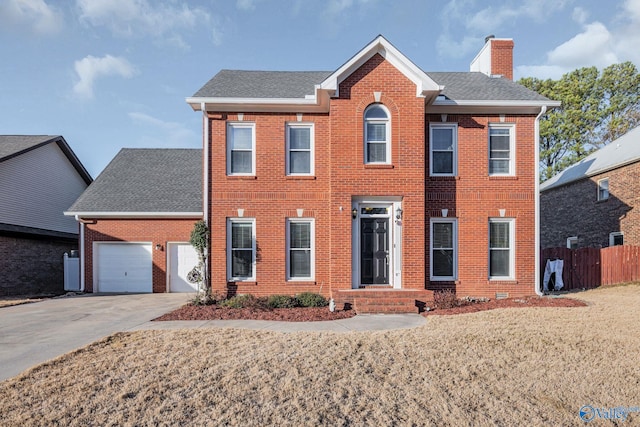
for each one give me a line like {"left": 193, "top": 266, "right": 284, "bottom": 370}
{"left": 65, "top": 149, "right": 202, "bottom": 293}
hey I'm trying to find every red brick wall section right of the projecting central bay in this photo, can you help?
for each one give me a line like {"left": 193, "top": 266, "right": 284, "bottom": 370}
{"left": 425, "top": 114, "right": 536, "bottom": 298}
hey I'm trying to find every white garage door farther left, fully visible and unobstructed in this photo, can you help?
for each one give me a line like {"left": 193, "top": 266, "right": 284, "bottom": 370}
{"left": 95, "top": 243, "right": 153, "bottom": 292}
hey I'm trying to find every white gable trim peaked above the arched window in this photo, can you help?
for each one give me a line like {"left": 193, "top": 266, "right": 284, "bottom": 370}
{"left": 320, "top": 36, "right": 441, "bottom": 97}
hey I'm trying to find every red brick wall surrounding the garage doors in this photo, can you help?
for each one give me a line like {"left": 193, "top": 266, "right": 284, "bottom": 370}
{"left": 85, "top": 219, "right": 197, "bottom": 292}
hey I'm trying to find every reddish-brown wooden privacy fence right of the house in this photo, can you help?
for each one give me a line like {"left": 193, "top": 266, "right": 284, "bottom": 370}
{"left": 540, "top": 246, "right": 640, "bottom": 291}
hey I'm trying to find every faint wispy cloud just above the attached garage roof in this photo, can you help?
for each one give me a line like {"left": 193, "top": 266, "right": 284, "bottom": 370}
{"left": 129, "top": 111, "right": 194, "bottom": 147}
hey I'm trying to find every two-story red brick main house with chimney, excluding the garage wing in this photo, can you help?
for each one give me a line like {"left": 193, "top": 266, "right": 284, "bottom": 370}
{"left": 187, "top": 36, "right": 558, "bottom": 307}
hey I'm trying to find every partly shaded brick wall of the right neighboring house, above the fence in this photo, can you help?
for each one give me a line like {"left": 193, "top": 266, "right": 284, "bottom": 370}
{"left": 540, "top": 162, "right": 640, "bottom": 248}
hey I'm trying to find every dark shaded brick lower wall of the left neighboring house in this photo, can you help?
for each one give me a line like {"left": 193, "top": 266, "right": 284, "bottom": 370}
{"left": 0, "top": 236, "right": 78, "bottom": 296}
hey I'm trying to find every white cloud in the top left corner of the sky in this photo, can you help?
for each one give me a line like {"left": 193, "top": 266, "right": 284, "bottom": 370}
{"left": 0, "top": 0, "right": 64, "bottom": 35}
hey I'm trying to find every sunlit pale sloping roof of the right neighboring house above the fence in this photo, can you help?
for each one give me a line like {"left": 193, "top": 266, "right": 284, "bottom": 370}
{"left": 540, "top": 127, "right": 640, "bottom": 191}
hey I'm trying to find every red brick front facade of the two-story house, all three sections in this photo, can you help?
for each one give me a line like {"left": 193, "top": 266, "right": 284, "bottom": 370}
{"left": 207, "top": 54, "right": 536, "bottom": 298}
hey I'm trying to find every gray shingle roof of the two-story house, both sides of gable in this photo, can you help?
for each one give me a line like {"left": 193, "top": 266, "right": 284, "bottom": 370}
{"left": 194, "top": 70, "right": 548, "bottom": 101}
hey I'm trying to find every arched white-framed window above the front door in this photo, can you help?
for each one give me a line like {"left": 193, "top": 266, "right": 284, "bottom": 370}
{"left": 364, "top": 104, "right": 391, "bottom": 164}
